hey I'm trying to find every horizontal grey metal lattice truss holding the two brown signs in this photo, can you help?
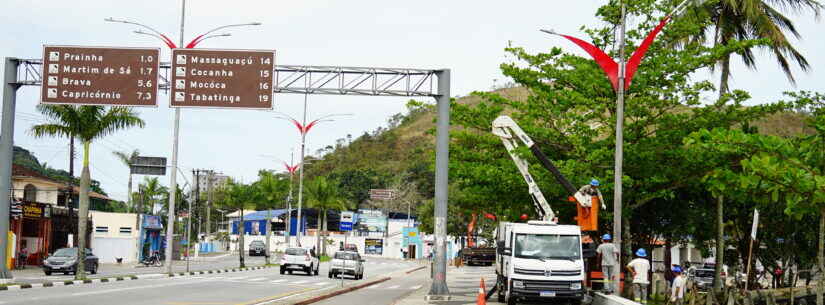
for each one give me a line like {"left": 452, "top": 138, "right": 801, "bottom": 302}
{"left": 12, "top": 59, "right": 438, "bottom": 96}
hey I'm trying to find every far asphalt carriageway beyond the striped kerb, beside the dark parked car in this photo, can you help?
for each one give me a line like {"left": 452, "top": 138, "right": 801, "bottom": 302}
{"left": 13, "top": 253, "right": 268, "bottom": 284}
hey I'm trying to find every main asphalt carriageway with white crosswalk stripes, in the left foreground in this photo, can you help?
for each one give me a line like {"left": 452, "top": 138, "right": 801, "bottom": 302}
{"left": 0, "top": 258, "right": 423, "bottom": 305}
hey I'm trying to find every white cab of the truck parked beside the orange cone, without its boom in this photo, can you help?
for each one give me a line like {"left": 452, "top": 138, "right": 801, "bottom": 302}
{"left": 496, "top": 221, "right": 587, "bottom": 305}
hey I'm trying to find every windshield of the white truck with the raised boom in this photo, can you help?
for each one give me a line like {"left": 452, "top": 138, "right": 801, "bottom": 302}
{"left": 514, "top": 234, "right": 581, "bottom": 260}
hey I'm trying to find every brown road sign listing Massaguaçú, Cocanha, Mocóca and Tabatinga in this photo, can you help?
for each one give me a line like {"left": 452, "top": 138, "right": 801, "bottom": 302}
{"left": 170, "top": 49, "right": 275, "bottom": 109}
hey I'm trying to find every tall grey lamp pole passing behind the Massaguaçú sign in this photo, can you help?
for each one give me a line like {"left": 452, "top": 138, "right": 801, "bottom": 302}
{"left": 166, "top": 0, "right": 186, "bottom": 274}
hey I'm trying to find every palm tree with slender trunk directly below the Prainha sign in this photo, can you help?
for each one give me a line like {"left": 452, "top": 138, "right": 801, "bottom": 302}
{"left": 31, "top": 105, "right": 145, "bottom": 279}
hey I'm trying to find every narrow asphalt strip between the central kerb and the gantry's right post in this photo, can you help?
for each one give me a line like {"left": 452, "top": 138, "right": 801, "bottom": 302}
{"left": 315, "top": 268, "right": 430, "bottom": 305}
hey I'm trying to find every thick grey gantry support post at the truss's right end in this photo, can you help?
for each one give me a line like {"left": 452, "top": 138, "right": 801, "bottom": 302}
{"left": 427, "top": 69, "right": 450, "bottom": 300}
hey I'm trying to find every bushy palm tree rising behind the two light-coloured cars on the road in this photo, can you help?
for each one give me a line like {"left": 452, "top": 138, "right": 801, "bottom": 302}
{"left": 306, "top": 176, "right": 349, "bottom": 254}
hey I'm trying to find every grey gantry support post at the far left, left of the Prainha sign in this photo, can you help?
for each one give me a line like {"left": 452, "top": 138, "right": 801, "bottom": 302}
{"left": 0, "top": 57, "right": 20, "bottom": 284}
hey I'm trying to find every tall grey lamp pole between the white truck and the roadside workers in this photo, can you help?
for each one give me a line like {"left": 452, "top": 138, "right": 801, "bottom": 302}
{"left": 612, "top": 1, "right": 627, "bottom": 295}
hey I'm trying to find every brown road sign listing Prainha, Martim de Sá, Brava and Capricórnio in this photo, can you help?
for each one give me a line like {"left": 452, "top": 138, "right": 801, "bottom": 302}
{"left": 40, "top": 46, "right": 160, "bottom": 106}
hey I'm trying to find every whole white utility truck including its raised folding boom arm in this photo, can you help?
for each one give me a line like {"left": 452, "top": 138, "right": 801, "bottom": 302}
{"left": 493, "top": 116, "right": 598, "bottom": 304}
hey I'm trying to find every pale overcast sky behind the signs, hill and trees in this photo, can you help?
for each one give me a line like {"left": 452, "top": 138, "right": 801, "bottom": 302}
{"left": 0, "top": 0, "right": 825, "bottom": 200}
